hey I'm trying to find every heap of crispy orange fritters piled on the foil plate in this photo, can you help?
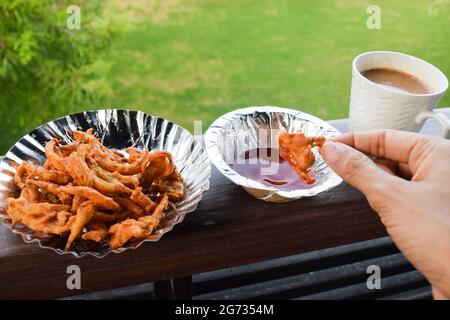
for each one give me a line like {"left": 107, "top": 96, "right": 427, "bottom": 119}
{"left": 7, "top": 129, "right": 185, "bottom": 251}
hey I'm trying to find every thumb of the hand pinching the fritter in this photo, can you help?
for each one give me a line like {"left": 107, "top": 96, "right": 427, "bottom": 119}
{"left": 320, "top": 141, "right": 395, "bottom": 198}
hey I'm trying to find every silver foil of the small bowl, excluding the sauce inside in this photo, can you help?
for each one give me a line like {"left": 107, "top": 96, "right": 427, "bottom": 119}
{"left": 205, "top": 106, "right": 342, "bottom": 202}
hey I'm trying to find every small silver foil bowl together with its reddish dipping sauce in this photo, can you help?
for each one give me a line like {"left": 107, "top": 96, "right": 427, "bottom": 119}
{"left": 205, "top": 106, "right": 342, "bottom": 202}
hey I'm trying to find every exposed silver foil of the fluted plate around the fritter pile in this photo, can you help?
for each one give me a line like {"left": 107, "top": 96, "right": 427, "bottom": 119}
{"left": 0, "top": 109, "right": 211, "bottom": 257}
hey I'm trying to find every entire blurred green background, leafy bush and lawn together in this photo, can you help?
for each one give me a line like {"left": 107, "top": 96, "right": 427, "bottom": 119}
{"left": 0, "top": 0, "right": 450, "bottom": 154}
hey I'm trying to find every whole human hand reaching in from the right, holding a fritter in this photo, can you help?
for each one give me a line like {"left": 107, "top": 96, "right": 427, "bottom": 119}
{"left": 320, "top": 130, "right": 450, "bottom": 299}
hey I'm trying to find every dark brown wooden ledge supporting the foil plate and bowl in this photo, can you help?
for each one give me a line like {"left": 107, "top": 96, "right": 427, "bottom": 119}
{"left": 0, "top": 109, "right": 450, "bottom": 299}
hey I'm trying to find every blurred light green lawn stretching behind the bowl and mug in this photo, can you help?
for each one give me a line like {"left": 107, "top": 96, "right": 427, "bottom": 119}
{"left": 104, "top": 0, "right": 450, "bottom": 130}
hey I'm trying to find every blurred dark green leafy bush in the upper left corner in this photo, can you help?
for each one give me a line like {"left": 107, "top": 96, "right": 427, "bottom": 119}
{"left": 0, "top": 0, "right": 111, "bottom": 153}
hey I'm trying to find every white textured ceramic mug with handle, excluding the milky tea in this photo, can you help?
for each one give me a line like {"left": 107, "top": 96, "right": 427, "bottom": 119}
{"left": 349, "top": 51, "right": 450, "bottom": 138}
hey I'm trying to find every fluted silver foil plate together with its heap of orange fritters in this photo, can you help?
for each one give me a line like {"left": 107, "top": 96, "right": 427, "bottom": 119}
{"left": 0, "top": 109, "right": 211, "bottom": 257}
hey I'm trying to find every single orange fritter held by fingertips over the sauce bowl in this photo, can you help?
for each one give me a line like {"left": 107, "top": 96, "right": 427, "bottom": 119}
{"left": 277, "top": 131, "right": 325, "bottom": 184}
